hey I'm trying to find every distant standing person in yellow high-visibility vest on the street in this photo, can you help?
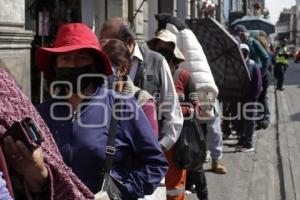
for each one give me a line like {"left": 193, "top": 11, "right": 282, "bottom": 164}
{"left": 274, "top": 39, "right": 288, "bottom": 91}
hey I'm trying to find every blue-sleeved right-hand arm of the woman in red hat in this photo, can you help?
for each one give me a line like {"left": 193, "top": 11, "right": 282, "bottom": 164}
{"left": 121, "top": 100, "right": 168, "bottom": 199}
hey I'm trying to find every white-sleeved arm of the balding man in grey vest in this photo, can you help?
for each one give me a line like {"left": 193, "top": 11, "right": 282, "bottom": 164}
{"left": 158, "top": 59, "right": 183, "bottom": 150}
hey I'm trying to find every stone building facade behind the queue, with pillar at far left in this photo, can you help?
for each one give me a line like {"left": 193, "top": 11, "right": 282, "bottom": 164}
{"left": 0, "top": 0, "right": 224, "bottom": 101}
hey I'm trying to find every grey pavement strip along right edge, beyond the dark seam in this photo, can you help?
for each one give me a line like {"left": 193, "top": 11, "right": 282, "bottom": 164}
{"left": 276, "top": 86, "right": 300, "bottom": 200}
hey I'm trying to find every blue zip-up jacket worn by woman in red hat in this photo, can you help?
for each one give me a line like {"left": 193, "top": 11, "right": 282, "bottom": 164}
{"left": 38, "top": 88, "right": 168, "bottom": 199}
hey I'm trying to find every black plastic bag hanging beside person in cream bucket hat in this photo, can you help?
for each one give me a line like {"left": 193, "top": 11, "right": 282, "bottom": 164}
{"left": 173, "top": 118, "right": 206, "bottom": 170}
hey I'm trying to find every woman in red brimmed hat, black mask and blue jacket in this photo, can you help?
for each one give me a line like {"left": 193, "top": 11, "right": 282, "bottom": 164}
{"left": 36, "top": 23, "right": 167, "bottom": 200}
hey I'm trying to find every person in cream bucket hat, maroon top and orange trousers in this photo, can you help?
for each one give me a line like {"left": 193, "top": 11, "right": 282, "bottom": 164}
{"left": 147, "top": 29, "right": 207, "bottom": 200}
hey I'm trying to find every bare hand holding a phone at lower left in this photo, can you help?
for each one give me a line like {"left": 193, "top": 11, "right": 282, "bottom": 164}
{"left": 4, "top": 136, "right": 48, "bottom": 193}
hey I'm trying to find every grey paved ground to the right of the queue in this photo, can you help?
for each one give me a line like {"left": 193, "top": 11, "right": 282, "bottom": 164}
{"left": 187, "top": 62, "right": 300, "bottom": 200}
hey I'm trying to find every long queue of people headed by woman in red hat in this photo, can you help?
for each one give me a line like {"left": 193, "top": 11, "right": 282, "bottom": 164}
{"left": 0, "top": 14, "right": 282, "bottom": 200}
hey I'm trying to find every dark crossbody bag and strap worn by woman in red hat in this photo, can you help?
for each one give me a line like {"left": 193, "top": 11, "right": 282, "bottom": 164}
{"left": 95, "top": 98, "right": 129, "bottom": 200}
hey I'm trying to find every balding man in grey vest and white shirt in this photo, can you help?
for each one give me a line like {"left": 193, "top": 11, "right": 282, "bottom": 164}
{"left": 100, "top": 17, "right": 183, "bottom": 151}
